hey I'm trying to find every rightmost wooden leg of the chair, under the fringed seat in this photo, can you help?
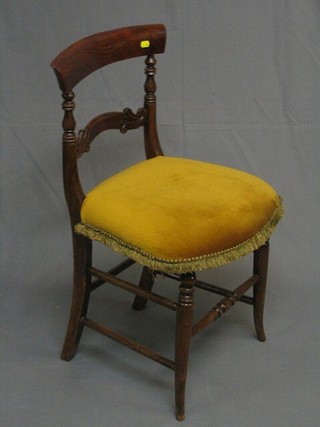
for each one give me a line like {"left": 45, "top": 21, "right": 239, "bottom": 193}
{"left": 253, "top": 242, "right": 269, "bottom": 341}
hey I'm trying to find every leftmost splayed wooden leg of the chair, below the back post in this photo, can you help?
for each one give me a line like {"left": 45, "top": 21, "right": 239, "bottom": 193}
{"left": 61, "top": 234, "right": 92, "bottom": 361}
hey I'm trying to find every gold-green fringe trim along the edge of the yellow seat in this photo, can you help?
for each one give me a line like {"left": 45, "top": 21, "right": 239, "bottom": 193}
{"left": 75, "top": 199, "right": 284, "bottom": 274}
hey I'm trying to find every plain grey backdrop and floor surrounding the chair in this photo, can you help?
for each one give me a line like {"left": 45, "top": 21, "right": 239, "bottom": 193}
{"left": 0, "top": 0, "right": 320, "bottom": 427}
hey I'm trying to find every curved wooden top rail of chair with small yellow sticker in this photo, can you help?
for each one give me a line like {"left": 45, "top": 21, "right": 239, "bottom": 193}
{"left": 51, "top": 24, "right": 166, "bottom": 92}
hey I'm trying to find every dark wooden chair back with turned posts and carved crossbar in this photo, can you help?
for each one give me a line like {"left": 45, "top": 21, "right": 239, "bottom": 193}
{"left": 51, "top": 24, "right": 166, "bottom": 224}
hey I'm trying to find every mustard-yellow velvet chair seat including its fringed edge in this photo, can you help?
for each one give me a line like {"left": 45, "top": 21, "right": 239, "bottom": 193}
{"left": 76, "top": 156, "right": 282, "bottom": 273}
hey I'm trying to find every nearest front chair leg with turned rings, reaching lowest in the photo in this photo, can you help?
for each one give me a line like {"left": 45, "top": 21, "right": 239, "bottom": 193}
{"left": 175, "top": 274, "right": 196, "bottom": 421}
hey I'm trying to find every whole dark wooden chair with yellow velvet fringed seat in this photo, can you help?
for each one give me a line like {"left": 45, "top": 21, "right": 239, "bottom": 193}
{"left": 51, "top": 24, "right": 282, "bottom": 420}
